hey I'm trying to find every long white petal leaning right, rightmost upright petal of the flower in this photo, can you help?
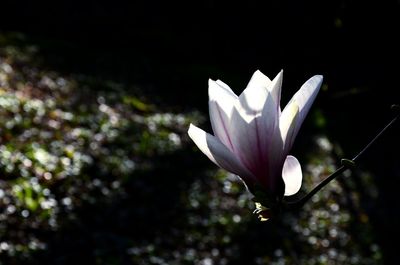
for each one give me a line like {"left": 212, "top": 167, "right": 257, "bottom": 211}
{"left": 282, "top": 75, "right": 323, "bottom": 146}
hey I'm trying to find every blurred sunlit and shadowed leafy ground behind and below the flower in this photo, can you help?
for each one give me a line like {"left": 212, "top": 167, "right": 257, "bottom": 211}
{"left": 0, "top": 37, "right": 382, "bottom": 265}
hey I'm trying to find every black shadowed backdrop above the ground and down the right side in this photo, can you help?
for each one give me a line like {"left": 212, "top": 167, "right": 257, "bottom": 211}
{"left": 0, "top": 0, "right": 400, "bottom": 264}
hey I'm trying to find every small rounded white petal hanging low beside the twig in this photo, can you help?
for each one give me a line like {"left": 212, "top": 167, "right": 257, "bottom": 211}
{"left": 282, "top": 155, "right": 303, "bottom": 196}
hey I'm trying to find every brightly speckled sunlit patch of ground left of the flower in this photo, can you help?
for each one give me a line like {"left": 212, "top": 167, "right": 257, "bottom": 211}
{"left": 0, "top": 41, "right": 200, "bottom": 256}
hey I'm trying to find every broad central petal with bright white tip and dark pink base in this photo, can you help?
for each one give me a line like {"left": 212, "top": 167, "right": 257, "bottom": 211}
{"left": 231, "top": 71, "right": 278, "bottom": 175}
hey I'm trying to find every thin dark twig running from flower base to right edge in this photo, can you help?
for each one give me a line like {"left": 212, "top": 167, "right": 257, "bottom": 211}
{"left": 287, "top": 105, "right": 400, "bottom": 209}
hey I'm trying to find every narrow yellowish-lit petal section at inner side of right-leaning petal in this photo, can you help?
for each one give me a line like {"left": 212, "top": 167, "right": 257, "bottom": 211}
{"left": 279, "top": 100, "right": 299, "bottom": 156}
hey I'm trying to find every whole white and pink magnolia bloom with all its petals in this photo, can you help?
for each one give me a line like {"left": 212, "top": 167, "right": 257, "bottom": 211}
{"left": 188, "top": 70, "right": 322, "bottom": 200}
